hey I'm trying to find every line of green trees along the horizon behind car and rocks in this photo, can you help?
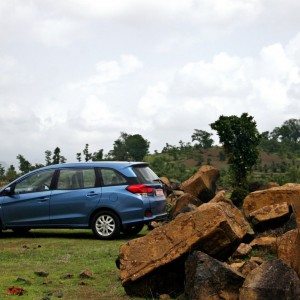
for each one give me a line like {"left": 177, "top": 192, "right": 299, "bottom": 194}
{"left": 0, "top": 113, "right": 300, "bottom": 197}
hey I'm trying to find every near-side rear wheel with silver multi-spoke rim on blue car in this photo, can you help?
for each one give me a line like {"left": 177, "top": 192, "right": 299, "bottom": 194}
{"left": 92, "top": 211, "right": 121, "bottom": 240}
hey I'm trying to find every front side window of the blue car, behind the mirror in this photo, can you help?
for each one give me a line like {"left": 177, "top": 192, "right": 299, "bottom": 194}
{"left": 15, "top": 170, "right": 54, "bottom": 194}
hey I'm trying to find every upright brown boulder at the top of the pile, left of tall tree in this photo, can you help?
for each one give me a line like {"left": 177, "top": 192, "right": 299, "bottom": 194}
{"left": 180, "top": 166, "right": 220, "bottom": 202}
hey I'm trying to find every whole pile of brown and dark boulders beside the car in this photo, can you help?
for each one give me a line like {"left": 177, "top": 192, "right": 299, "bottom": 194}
{"left": 118, "top": 166, "right": 300, "bottom": 300}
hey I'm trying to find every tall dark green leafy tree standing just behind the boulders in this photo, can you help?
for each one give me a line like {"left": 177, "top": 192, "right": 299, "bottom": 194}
{"left": 210, "top": 113, "right": 260, "bottom": 188}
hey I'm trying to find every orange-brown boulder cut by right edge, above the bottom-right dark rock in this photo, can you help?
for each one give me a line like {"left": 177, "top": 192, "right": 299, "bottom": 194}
{"left": 277, "top": 229, "right": 300, "bottom": 277}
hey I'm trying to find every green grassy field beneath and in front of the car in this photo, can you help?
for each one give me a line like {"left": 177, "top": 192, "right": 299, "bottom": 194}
{"left": 0, "top": 230, "right": 145, "bottom": 300}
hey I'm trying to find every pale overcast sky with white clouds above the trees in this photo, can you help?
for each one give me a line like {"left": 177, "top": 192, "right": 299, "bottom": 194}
{"left": 0, "top": 0, "right": 300, "bottom": 163}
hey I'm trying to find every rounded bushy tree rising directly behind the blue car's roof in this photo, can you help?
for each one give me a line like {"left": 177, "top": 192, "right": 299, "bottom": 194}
{"left": 108, "top": 132, "right": 150, "bottom": 161}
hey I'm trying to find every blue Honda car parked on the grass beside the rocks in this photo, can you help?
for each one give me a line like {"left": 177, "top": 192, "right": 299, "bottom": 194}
{"left": 0, "top": 161, "right": 167, "bottom": 239}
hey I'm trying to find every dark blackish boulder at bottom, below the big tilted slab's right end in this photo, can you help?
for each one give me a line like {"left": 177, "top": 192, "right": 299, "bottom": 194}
{"left": 185, "top": 251, "right": 245, "bottom": 300}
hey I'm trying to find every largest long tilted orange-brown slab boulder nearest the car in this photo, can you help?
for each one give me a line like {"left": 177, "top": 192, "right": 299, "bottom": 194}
{"left": 119, "top": 202, "right": 252, "bottom": 297}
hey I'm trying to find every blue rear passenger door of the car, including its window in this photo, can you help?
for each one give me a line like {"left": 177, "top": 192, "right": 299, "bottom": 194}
{"left": 50, "top": 168, "right": 101, "bottom": 227}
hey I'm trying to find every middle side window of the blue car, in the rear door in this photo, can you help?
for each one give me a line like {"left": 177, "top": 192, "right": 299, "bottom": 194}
{"left": 57, "top": 169, "right": 96, "bottom": 190}
